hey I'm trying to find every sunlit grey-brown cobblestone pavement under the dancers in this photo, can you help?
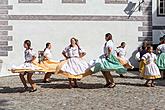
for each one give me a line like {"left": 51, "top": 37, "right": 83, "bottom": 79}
{"left": 0, "top": 72, "right": 165, "bottom": 110}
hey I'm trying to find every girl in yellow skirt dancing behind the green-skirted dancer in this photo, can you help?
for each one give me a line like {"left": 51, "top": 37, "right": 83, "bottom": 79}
{"left": 116, "top": 42, "right": 134, "bottom": 69}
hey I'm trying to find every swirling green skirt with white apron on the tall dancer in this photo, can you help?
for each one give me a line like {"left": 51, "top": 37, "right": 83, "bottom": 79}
{"left": 91, "top": 54, "right": 127, "bottom": 74}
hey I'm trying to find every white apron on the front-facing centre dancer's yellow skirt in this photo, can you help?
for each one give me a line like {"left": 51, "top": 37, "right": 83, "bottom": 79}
{"left": 61, "top": 58, "right": 90, "bottom": 75}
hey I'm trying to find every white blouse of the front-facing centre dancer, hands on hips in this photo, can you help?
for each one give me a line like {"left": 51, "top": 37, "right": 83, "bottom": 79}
{"left": 63, "top": 46, "right": 85, "bottom": 58}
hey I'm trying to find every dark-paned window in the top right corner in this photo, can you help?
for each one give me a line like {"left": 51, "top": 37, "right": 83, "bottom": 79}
{"left": 158, "top": 0, "right": 165, "bottom": 16}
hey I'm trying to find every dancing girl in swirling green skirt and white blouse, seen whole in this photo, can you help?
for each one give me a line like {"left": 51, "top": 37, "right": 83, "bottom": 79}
{"left": 91, "top": 33, "right": 127, "bottom": 88}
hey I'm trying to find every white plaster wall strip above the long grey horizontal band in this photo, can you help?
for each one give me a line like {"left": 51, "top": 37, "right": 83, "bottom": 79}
{"left": 9, "top": 0, "right": 142, "bottom": 16}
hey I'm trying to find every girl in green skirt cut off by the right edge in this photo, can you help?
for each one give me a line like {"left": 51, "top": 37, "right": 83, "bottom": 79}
{"left": 156, "top": 36, "right": 165, "bottom": 78}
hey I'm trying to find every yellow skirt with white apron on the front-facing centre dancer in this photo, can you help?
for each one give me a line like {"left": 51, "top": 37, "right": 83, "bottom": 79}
{"left": 56, "top": 58, "right": 92, "bottom": 79}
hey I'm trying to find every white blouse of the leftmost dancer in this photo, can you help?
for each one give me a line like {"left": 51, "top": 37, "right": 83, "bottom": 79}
{"left": 24, "top": 49, "right": 36, "bottom": 62}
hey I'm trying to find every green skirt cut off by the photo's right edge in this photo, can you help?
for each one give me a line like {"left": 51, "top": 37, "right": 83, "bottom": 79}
{"left": 156, "top": 53, "right": 165, "bottom": 70}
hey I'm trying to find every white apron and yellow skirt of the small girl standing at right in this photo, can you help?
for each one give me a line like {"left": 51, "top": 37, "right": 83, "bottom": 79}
{"left": 143, "top": 62, "right": 161, "bottom": 79}
